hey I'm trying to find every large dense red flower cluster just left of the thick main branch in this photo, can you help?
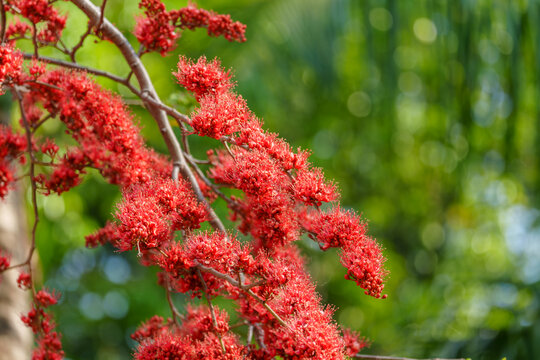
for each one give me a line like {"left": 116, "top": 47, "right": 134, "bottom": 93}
{"left": 20, "top": 70, "right": 171, "bottom": 194}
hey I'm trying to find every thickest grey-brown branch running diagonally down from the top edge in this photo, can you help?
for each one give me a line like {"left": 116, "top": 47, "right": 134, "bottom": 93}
{"left": 73, "top": 0, "right": 226, "bottom": 233}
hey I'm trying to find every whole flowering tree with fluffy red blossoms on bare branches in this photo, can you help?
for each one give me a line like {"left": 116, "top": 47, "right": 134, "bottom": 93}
{"left": 0, "top": 0, "right": 386, "bottom": 360}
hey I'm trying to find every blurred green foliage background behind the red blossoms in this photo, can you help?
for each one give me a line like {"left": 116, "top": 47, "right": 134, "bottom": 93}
{"left": 11, "top": 0, "right": 540, "bottom": 359}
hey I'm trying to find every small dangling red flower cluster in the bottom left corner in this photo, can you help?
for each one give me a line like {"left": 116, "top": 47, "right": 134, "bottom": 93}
{"left": 21, "top": 289, "right": 64, "bottom": 360}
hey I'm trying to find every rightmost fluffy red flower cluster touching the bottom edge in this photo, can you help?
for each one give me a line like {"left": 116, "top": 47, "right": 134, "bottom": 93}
{"left": 236, "top": 246, "right": 344, "bottom": 359}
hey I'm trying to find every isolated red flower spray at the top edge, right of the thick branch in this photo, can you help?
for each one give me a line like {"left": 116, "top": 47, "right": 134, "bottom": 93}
{"left": 134, "top": 0, "right": 246, "bottom": 56}
